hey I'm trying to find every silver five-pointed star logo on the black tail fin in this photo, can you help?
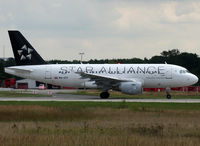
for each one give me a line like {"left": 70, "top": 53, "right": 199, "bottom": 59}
{"left": 18, "top": 45, "right": 33, "bottom": 60}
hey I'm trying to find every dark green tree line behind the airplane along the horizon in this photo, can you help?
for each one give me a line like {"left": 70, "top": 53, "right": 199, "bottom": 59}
{"left": 0, "top": 49, "right": 200, "bottom": 84}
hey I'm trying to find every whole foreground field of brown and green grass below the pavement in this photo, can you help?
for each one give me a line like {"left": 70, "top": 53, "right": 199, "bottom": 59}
{"left": 0, "top": 102, "right": 200, "bottom": 146}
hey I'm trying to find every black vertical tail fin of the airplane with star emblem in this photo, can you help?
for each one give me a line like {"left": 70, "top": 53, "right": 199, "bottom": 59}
{"left": 8, "top": 30, "right": 46, "bottom": 65}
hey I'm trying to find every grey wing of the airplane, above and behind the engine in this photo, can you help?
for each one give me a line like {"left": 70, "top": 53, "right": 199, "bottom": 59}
{"left": 76, "top": 72, "right": 134, "bottom": 88}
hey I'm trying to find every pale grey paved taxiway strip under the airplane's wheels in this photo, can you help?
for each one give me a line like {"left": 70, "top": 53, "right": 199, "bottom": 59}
{"left": 0, "top": 94, "right": 200, "bottom": 103}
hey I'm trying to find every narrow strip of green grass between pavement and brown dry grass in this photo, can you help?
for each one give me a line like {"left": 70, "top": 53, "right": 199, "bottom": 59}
{"left": 0, "top": 100, "right": 200, "bottom": 111}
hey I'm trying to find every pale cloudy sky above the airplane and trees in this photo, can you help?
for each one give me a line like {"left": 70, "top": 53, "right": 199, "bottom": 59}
{"left": 0, "top": 0, "right": 200, "bottom": 61}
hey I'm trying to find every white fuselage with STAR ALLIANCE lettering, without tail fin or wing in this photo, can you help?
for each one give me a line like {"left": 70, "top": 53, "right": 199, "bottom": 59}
{"left": 5, "top": 64, "right": 198, "bottom": 88}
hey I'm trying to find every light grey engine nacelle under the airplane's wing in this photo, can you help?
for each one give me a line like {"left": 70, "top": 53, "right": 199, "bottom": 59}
{"left": 119, "top": 82, "right": 142, "bottom": 95}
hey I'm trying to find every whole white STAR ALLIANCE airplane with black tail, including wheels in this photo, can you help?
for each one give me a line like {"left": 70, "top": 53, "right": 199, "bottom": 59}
{"left": 5, "top": 30, "right": 198, "bottom": 99}
